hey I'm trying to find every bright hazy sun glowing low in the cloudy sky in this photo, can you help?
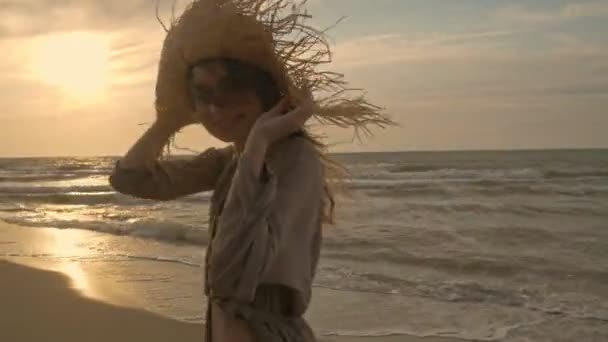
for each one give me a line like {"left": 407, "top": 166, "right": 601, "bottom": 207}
{"left": 31, "top": 32, "right": 110, "bottom": 101}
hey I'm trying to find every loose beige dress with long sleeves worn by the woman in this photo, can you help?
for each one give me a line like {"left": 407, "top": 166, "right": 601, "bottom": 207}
{"left": 110, "top": 136, "right": 324, "bottom": 342}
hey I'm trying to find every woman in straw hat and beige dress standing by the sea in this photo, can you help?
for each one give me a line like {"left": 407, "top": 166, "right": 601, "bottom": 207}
{"left": 110, "top": 0, "right": 391, "bottom": 342}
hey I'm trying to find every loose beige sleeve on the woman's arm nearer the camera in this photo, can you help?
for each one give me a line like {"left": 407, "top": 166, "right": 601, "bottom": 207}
{"left": 208, "top": 140, "right": 323, "bottom": 302}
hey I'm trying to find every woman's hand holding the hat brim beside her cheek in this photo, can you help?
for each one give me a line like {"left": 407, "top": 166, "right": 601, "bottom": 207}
{"left": 241, "top": 91, "right": 316, "bottom": 176}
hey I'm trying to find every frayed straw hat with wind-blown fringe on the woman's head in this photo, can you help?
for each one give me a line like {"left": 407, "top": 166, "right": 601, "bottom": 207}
{"left": 155, "top": 0, "right": 394, "bottom": 136}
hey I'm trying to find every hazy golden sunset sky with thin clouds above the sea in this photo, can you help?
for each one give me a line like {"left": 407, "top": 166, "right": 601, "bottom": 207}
{"left": 0, "top": 0, "right": 608, "bottom": 157}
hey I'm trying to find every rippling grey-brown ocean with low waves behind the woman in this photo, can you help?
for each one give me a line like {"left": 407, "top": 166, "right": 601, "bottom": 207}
{"left": 0, "top": 150, "right": 608, "bottom": 341}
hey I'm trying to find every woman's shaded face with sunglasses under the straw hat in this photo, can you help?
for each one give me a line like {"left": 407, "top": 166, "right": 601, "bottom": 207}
{"left": 190, "top": 62, "right": 262, "bottom": 143}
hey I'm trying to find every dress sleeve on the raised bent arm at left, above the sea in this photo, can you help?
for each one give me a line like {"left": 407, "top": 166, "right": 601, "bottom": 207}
{"left": 109, "top": 146, "right": 232, "bottom": 201}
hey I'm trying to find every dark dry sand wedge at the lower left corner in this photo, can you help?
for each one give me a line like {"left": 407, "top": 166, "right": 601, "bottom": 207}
{"left": 0, "top": 260, "right": 203, "bottom": 342}
